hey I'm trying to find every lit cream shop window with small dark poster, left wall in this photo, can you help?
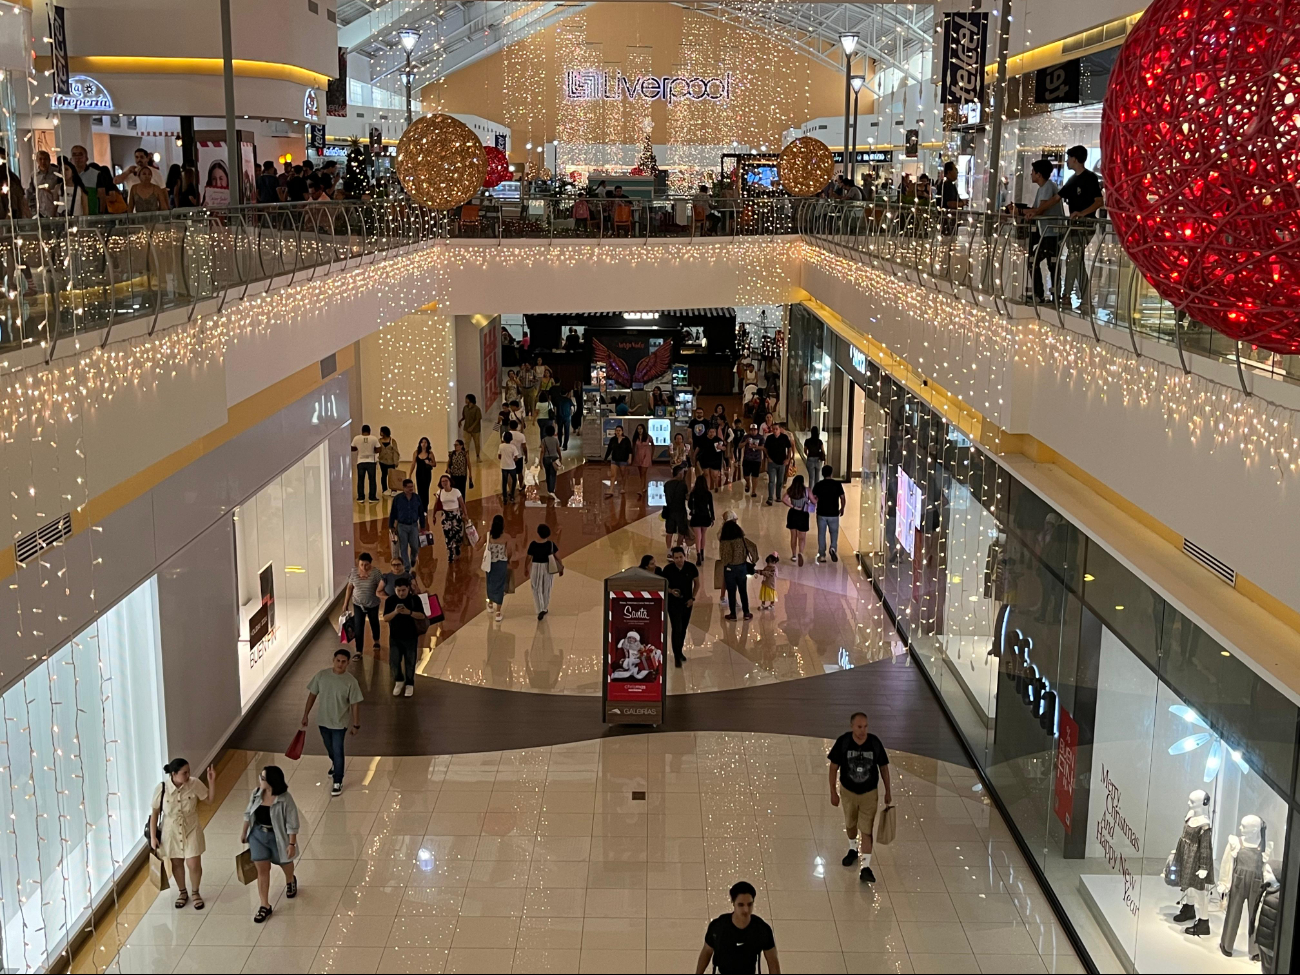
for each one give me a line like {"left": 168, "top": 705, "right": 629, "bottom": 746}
{"left": 234, "top": 443, "right": 334, "bottom": 709}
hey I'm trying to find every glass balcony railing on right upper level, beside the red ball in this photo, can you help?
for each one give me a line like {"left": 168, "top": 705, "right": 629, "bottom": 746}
{"left": 798, "top": 200, "right": 1300, "bottom": 389}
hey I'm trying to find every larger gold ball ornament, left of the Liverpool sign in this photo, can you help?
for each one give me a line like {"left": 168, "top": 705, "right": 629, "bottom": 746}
{"left": 398, "top": 116, "right": 488, "bottom": 209}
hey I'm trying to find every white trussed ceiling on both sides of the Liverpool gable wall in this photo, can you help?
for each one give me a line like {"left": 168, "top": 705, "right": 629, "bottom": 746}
{"left": 338, "top": 0, "right": 933, "bottom": 99}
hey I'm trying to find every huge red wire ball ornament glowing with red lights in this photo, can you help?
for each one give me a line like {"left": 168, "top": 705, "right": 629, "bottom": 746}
{"left": 1101, "top": 0, "right": 1300, "bottom": 354}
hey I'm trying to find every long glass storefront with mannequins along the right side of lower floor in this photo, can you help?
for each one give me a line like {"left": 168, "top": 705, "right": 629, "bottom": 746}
{"left": 792, "top": 305, "right": 1300, "bottom": 972}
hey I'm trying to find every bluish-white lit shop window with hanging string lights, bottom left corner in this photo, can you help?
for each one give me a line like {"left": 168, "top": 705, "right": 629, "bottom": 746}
{"left": 0, "top": 579, "right": 166, "bottom": 971}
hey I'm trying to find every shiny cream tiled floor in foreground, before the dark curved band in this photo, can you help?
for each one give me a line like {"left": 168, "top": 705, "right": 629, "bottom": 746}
{"left": 101, "top": 733, "right": 1083, "bottom": 975}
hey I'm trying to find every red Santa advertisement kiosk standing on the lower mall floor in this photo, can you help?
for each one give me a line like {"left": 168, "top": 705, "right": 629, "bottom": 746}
{"left": 601, "top": 568, "right": 668, "bottom": 724}
